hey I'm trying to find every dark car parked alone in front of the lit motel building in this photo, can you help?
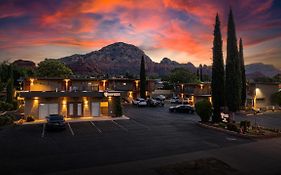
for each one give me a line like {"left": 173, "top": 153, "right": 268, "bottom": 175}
{"left": 46, "top": 114, "right": 66, "bottom": 130}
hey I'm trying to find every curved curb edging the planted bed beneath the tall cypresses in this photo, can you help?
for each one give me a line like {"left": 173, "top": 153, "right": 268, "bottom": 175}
{"left": 196, "top": 122, "right": 281, "bottom": 139}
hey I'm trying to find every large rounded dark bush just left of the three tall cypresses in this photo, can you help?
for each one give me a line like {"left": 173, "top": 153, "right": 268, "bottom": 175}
{"left": 195, "top": 100, "right": 213, "bottom": 122}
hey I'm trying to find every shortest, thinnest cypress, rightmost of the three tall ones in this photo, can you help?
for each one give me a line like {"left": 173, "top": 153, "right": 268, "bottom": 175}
{"left": 239, "top": 38, "right": 246, "bottom": 107}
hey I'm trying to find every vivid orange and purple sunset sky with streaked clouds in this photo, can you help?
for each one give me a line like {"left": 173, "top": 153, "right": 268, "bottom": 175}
{"left": 0, "top": 0, "right": 281, "bottom": 68}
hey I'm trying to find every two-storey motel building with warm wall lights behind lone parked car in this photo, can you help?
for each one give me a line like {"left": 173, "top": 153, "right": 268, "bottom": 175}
{"left": 18, "top": 78, "right": 121, "bottom": 120}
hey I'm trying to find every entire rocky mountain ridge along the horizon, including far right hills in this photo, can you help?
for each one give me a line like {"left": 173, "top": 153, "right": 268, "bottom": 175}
{"left": 10, "top": 42, "right": 281, "bottom": 78}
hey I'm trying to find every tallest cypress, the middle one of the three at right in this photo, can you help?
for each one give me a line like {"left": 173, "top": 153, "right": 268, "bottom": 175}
{"left": 225, "top": 9, "right": 241, "bottom": 112}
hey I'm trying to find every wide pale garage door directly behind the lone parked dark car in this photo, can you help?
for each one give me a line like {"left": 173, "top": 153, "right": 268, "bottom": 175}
{"left": 39, "top": 103, "right": 59, "bottom": 119}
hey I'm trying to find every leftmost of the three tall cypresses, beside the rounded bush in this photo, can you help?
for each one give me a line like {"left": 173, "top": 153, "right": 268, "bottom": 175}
{"left": 211, "top": 14, "right": 224, "bottom": 122}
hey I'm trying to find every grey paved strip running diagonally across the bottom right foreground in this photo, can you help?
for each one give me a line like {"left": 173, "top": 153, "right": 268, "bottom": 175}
{"left": 51, "top": 138, "right": 281, "bottom": 175}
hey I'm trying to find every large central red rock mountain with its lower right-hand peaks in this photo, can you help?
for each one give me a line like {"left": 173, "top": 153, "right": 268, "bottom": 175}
{"left": 60, "top": 42, "right": 196, "bottom": 76}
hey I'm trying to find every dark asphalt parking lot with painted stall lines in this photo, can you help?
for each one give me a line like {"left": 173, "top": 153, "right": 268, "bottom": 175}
{"left": 0, "top": 105, "right": 252, "bottom": 174}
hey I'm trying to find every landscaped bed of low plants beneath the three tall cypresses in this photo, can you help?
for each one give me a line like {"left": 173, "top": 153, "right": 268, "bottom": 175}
{"left": 198, "top": 121, "right": 281, "bottom": 139}
